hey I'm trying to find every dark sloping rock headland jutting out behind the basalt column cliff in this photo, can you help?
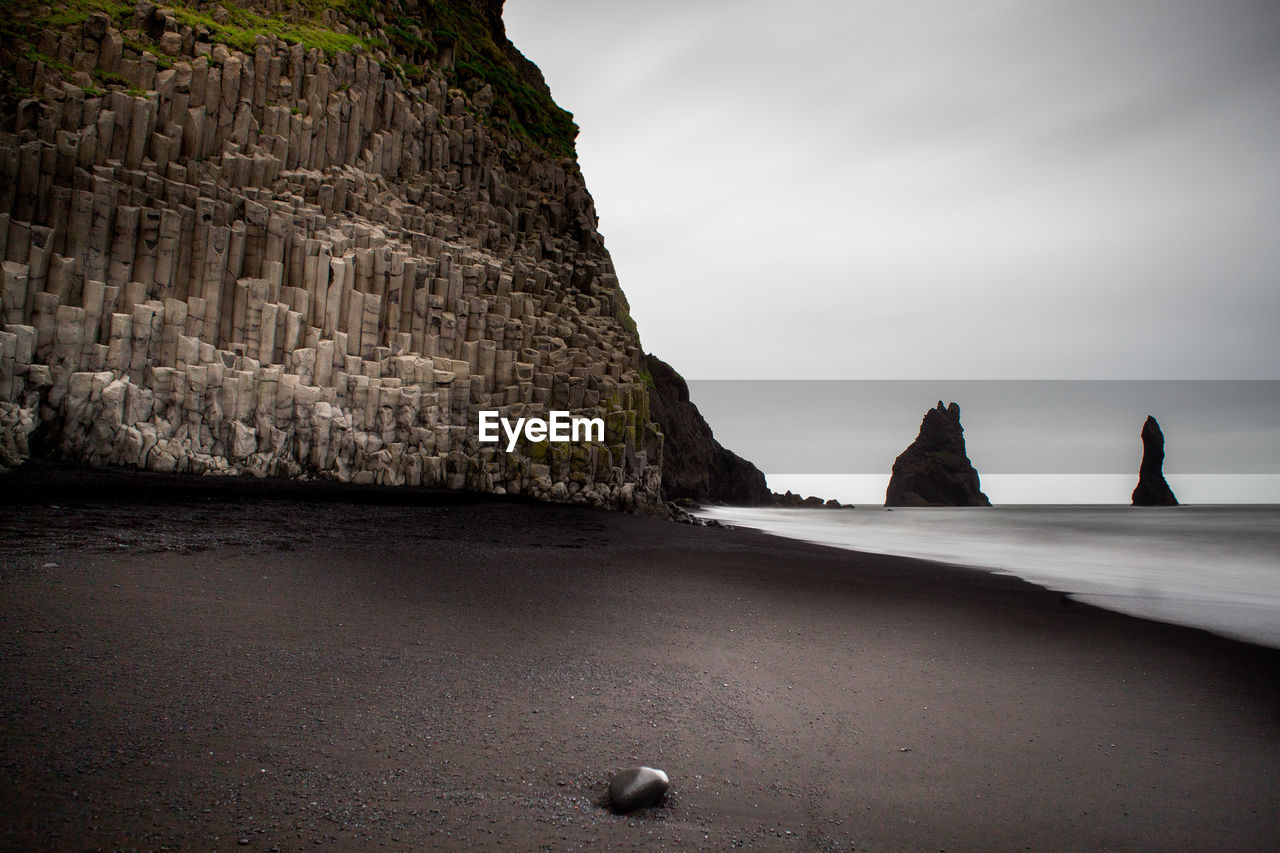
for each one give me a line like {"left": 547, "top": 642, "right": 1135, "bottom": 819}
{"left": 644, "top": 355, "right": 771, "bottom": 506}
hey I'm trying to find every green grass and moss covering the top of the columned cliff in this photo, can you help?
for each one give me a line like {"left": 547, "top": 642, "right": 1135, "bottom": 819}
{"left": 0, "top": 0, "right": 577, "bottom": 158}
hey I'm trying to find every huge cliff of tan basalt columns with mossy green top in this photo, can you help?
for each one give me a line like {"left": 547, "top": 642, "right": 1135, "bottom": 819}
{"left": 0, "top": 0, "right": 662, "bottom": 508}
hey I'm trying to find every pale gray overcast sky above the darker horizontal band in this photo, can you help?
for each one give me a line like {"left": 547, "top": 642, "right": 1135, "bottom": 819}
{"left": 504, "top": 0, "right": 1280, "bottom": 379}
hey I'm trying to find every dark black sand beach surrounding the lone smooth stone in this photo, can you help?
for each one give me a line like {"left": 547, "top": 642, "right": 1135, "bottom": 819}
{"left": 0, "top": 473, "right": 1280, "bottom": 850}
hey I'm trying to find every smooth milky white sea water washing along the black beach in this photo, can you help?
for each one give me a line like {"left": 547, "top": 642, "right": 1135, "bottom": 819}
{"left": 698, "top": 505, "right": 1280, "bottom": 648}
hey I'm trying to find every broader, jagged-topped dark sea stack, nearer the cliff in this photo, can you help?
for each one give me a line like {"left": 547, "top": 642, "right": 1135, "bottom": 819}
{"left": 884, "top": 400, "right": 991, "bottom": 506}
